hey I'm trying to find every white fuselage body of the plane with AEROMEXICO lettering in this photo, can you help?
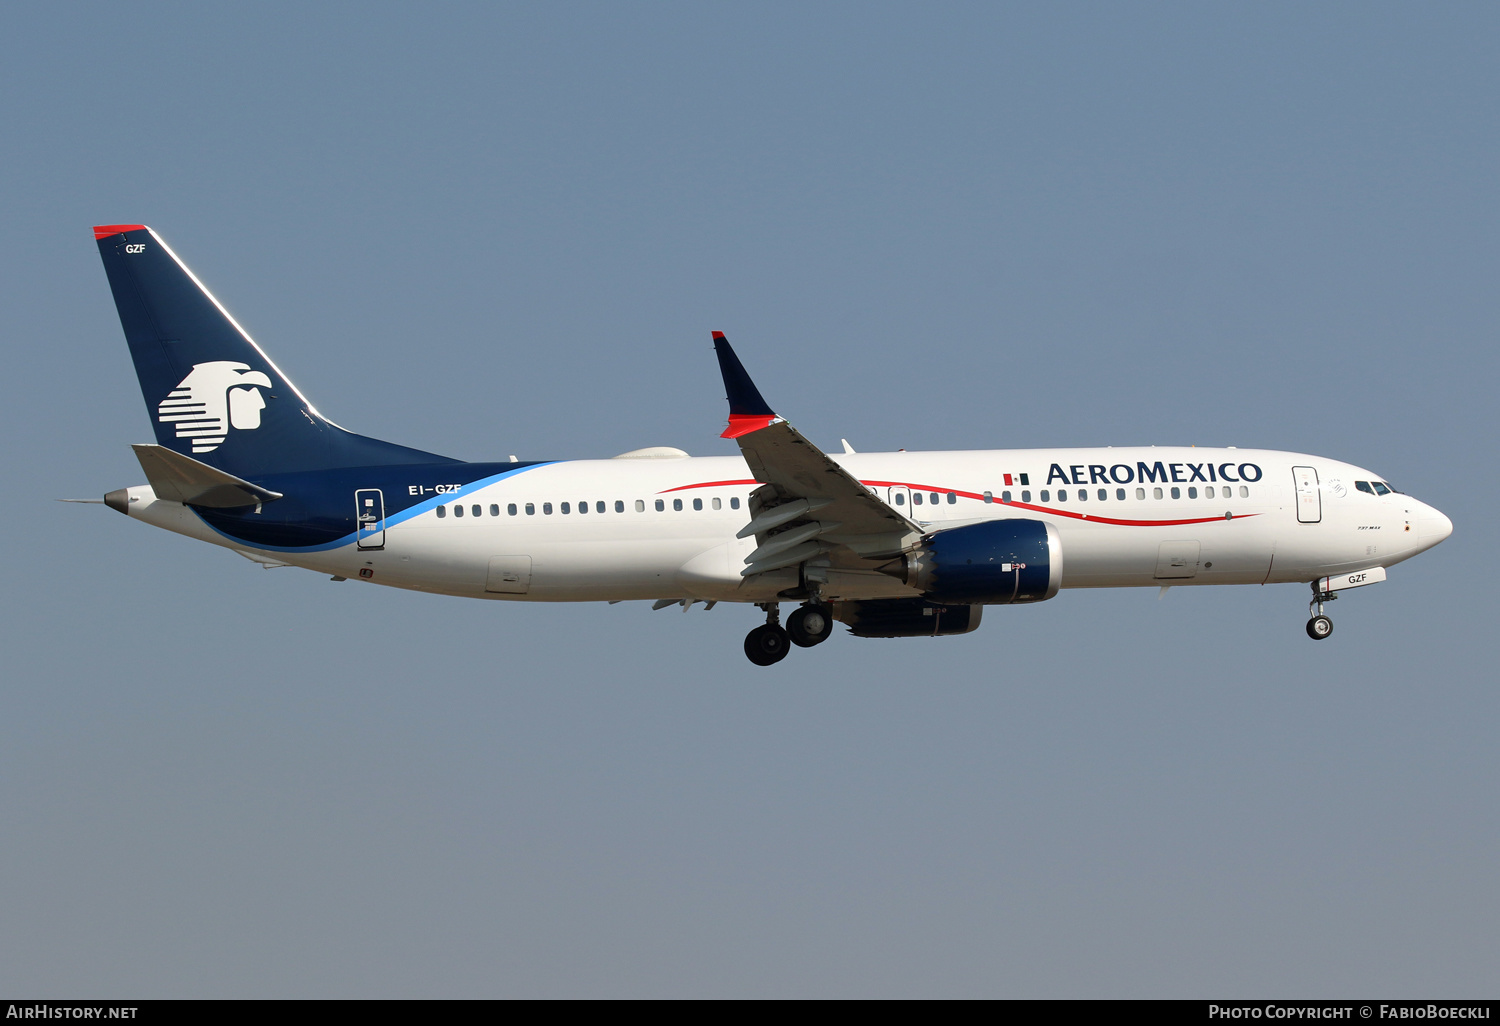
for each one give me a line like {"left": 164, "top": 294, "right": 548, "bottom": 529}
{"left": 117, "top": 447, "right": 1452, "bottom": 602}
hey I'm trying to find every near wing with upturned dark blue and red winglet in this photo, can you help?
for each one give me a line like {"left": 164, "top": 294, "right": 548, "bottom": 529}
{"left": 714, "top": 332, "right": 923, "bottom": 576}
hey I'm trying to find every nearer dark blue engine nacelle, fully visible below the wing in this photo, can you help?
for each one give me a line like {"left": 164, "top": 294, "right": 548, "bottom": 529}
{"left": 882, "top": 519, "right": 1062, "bottom": 606}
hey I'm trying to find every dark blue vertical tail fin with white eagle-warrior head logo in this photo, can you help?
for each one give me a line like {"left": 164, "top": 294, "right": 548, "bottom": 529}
{"left": 95, "top": 225, "right": 461, "bottom": 477}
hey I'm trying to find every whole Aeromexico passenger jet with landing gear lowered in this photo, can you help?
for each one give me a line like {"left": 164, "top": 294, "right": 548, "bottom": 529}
{"left": 89, "top": 225, "right": 1454, "bottom": 666}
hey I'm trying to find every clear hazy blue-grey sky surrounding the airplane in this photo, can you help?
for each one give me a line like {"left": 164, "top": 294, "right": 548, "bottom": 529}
{"left": 0, "top": 3, "right": 1500, "bottom": 996}
